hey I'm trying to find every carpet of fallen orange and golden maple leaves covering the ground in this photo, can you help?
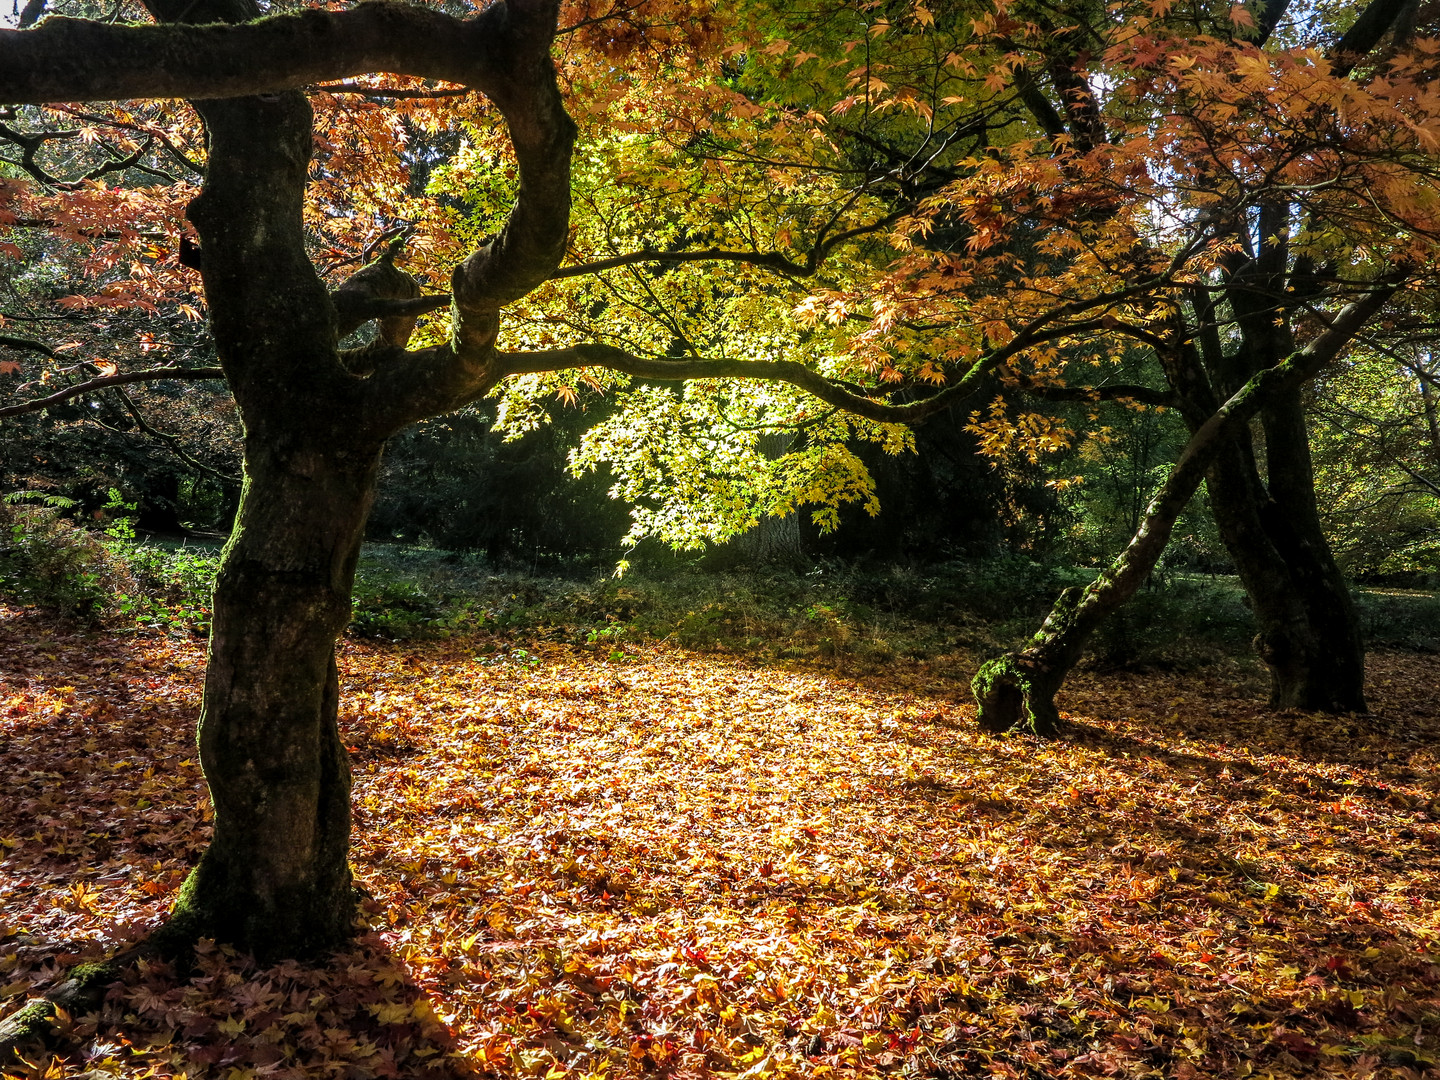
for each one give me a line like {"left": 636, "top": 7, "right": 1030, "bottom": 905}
{"left": 0, "top": 608, "right": 1440, "bottom": 1080}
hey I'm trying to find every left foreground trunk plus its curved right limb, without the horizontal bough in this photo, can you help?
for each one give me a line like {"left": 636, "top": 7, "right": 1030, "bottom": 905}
{"left": 132, "top": 0, "right": 575, "bottom": 958}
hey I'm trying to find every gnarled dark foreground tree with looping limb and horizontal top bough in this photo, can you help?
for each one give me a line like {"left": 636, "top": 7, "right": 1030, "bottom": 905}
{"left": 0, "top": 3, "right": 575, "bottom": 955}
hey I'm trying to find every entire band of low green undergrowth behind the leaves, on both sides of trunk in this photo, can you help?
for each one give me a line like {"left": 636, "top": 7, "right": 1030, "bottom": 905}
{"left": 0, "top": 515, "right": 1440, "bottom": 671}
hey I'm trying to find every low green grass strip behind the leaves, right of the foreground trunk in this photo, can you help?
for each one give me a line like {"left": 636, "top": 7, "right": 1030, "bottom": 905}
{"left": 351, "top": 546, "right": 1272, "bottom": 671}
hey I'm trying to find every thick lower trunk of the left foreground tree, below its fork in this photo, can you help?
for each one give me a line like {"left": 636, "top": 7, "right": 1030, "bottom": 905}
{"left": 171, "top": 442, "right": 380, "bottom": 956}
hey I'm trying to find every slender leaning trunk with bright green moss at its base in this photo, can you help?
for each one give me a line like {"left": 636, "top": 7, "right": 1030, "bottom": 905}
{"left": 971, "top": 285, "right": 1391, "bottom": 736}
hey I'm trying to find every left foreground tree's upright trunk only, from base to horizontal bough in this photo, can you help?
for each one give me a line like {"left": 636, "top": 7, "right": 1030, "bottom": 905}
{"left": 161, "top": 86, "right": 383, "bottom": 956}
